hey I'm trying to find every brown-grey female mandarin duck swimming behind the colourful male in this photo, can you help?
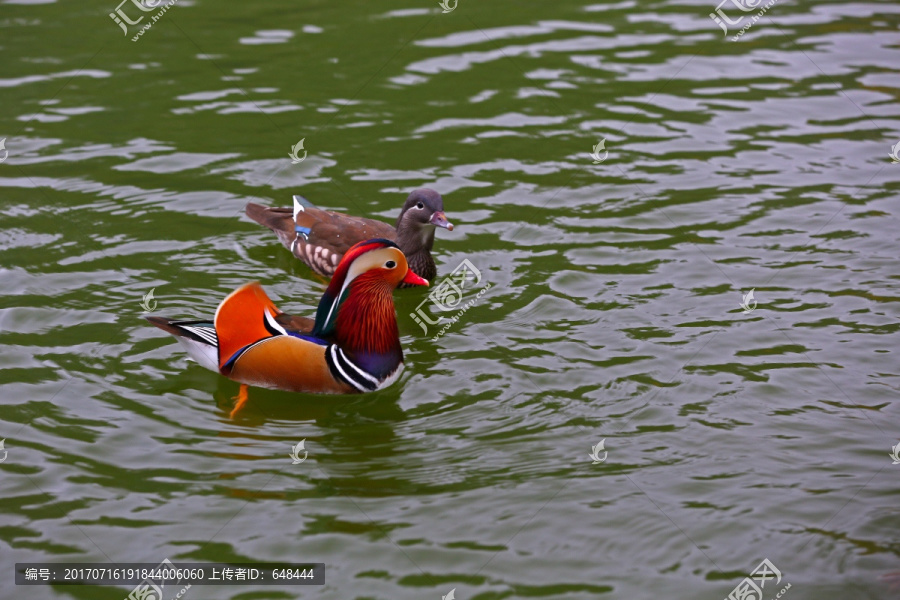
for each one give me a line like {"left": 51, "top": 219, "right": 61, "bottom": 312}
{"left": 246, "top": 188, "right": 453, "bottom": 287}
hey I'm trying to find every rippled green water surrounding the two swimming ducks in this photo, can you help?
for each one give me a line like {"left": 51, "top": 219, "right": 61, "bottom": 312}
{"left": 0, "top": 0, "right": 900, "bottom": 600}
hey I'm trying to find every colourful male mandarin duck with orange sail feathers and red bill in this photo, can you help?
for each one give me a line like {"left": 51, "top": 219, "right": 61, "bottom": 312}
{"left": 147, "top": 239, "right": 428, "bottom": 394}
